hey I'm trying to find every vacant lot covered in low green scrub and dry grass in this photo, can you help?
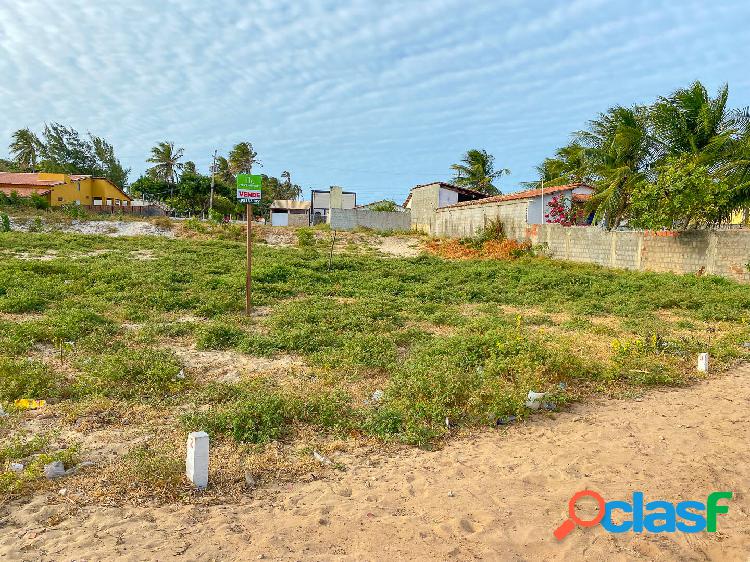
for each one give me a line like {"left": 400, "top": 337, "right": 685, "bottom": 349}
{"left": 0, "top": 230, "right": 750, "bottom": 504}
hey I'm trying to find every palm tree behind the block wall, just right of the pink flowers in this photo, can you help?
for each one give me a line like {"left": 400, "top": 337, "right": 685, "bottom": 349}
{"left": 577, "top": 106, "right": 654, "bottom": 228}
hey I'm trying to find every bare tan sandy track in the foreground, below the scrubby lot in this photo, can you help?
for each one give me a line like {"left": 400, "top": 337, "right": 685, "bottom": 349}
{"left": 0, "top": 360, "right": 750, "bottom": 561}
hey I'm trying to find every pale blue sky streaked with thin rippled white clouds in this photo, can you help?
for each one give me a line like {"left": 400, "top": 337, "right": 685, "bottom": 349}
{"left": 0, "top": 0, "right": 750, "bottom": 203}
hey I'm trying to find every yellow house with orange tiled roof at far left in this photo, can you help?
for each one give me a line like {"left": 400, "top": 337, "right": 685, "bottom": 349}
{"left": 0, "top": 172, "right": 133, "bottom": 209}
